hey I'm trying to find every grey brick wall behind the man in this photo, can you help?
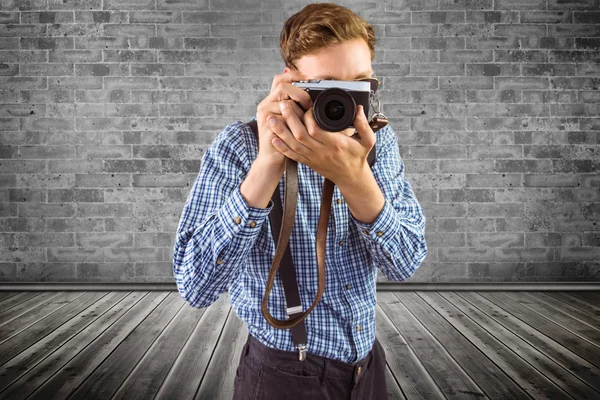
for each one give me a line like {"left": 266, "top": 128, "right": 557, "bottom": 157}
{"left": 0, "top": 0, "right": 600, "bottom": 282}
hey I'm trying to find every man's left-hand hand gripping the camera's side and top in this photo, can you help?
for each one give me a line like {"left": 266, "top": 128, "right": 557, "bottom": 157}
{"left": 256, "top": 69, "right": 312, "bottom": 170}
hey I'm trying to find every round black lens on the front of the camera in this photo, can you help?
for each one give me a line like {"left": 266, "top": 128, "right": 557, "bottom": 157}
{"left": 313, "top": 88, "right": 356, "bottom": 132}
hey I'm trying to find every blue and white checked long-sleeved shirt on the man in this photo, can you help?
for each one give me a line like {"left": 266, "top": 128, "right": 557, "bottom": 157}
{"left": 173, "top": 121, "right": 427, "bottom": 363}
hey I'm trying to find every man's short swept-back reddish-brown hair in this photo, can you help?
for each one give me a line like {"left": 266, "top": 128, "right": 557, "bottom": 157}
{"left": 279, "top": 3, "right": 375, "bottom": 69}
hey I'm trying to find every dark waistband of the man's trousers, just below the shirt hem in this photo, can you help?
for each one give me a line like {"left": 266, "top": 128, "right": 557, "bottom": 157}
{"left": 244, "top": 333, "right": 377, "bottom": 379}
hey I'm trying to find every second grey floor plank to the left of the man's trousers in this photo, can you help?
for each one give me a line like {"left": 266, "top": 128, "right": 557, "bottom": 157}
{"left": 155, "top": 293, "right": 233, "bottom": 400}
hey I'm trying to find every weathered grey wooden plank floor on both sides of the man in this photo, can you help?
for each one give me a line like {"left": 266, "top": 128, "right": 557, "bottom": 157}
{"left": 0, "top": 291, "right": 600, "bottom": 400}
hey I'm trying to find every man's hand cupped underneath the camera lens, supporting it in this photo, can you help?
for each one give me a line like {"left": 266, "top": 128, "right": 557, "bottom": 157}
{"left": 272, "top": 101, "right": 376, "bottom": 186}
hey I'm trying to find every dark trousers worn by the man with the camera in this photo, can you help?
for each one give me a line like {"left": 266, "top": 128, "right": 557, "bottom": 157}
{"left": 233, "top": 334, "right": 388, "bottom": 400}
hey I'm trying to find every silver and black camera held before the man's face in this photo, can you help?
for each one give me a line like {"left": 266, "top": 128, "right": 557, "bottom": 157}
{"left": 292, "top": 79, "right": 371, "bottom": 132}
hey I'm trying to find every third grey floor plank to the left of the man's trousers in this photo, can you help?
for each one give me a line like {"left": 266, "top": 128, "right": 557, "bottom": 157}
{"left": 112, "top": 292, "right": 204, "bottom": 399}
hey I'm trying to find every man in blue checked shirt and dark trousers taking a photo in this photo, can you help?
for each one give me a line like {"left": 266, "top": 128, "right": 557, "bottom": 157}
{"left": 173, "top": 4, "right": 427, "bottom": 399}
